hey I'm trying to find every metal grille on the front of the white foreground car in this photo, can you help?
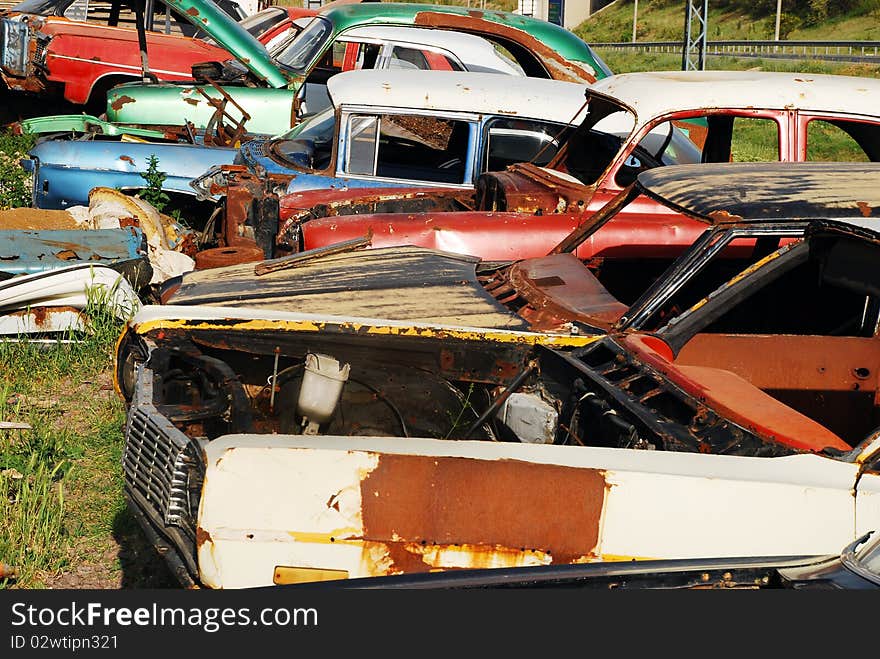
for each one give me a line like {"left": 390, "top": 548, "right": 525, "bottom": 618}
{"left": 122, "top": 367, "right": 204, "bottom": 541}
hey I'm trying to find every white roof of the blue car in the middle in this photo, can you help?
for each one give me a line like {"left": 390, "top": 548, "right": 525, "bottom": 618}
{"left": 327, "top": 69, "right": 587, "bottom": 124}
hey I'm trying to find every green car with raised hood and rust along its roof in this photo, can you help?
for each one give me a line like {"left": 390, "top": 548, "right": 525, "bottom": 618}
{"left": 107, "top": 0, "right": 611, "bottom": 134}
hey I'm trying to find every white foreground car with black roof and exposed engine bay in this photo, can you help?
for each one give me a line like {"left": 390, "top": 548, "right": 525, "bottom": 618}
{"left": 117, "top": 164, "right": 880, "bottom": 588}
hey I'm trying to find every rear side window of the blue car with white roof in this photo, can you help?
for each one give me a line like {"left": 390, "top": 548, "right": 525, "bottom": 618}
{"left": 483, "top": 118, "right": 573, "bottom": 172}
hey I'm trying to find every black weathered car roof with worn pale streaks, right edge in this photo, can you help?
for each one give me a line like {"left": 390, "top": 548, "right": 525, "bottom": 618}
{"left": 636, "top": 162, "right": 880, "bottom": 229}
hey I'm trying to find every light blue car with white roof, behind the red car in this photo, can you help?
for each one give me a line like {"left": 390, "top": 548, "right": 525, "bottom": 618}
{"left": 23, "top": 67, "right": 584, "bottom": 220}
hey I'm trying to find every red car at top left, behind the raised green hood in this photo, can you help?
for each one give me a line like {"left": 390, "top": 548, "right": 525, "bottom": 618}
{"left": 0, "top": 0, "right": 316, "bottom": 114}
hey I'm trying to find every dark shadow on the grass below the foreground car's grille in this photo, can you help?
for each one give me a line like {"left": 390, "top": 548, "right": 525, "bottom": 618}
{"left": 113, "top": 508, "right": 180, "bottom": 588}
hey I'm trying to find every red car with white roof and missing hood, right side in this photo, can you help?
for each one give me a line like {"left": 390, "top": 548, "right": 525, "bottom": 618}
{"left": 276, "top": 71, "right": 880, "bottom": 259}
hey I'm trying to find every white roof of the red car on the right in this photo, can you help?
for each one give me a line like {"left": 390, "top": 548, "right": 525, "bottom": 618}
{"left": 592, "top": 71, "right": 880, "bottom": 122}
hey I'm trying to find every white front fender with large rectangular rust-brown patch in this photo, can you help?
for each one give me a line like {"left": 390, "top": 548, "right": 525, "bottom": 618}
{"left": 192, "top": 435, "right": 880, "bottom": 588}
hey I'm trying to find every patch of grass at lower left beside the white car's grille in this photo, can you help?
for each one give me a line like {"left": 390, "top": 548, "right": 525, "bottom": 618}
{"left": 0, "top": 284, "right": 132, "bottom": 587}
